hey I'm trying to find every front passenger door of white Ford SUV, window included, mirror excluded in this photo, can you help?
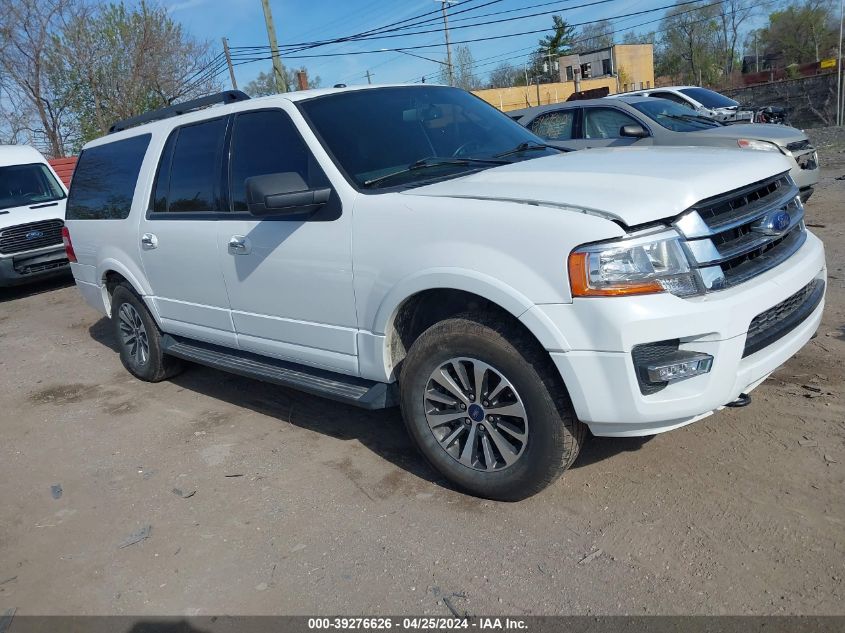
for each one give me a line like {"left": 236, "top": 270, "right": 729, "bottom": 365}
{"left": 218, "top": 109, "right": 358, "bottom": 374}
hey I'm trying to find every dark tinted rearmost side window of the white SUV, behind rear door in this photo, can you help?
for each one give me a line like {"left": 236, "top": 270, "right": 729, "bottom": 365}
{"left": 67, "top": 134, "right": 150, "bottom": 220}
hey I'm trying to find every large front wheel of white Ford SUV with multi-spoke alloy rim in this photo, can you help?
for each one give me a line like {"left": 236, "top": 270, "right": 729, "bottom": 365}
{"left": 400, "top": 314, "right": 587, "bottom": 501}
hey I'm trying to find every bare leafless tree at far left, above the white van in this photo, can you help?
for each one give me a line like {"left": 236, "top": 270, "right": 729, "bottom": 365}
{"left": 0, "top": 0, "right": 80, "bottom": 156}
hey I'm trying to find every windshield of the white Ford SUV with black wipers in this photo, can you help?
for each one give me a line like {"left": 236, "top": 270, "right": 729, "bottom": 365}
{"left": 298, "top": 86, "right": 557, "bottom": 189}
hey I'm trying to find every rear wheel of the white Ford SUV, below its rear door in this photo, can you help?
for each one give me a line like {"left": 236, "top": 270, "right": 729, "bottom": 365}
{"left": 112, "top": 283, "right": 182, "bottom": 382}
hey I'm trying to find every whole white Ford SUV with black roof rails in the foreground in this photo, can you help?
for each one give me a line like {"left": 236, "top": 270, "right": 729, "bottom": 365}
{"left": 67, "top": 86, "right": 826, "bottom": 499}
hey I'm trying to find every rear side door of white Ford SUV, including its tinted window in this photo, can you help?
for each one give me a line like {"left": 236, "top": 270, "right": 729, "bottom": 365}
{"left": 139, "top": 117, "right": 237, "bottom": 347}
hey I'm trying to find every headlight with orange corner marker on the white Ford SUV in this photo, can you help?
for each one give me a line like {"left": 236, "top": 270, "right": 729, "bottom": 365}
{"left": 569, "top": 230, "right": 702, "bottom": 297}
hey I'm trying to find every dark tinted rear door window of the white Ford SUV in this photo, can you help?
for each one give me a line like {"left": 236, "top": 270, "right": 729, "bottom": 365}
{"left": 153, "top": 117, "right": 227, "bottom": 213}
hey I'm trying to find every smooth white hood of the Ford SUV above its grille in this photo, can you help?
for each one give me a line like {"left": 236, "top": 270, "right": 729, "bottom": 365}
{"left": 403, "top": 147, "right": 790, "bottom": 226}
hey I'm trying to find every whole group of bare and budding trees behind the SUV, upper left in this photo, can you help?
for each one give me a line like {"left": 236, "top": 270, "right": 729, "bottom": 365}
{"left": 0, "top": 0, "right": 319, "bottom": 156}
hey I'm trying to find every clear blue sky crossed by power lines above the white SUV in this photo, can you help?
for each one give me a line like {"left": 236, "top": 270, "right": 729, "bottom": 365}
{"left": 163, "top": 0, "right": 760, "bottom": 87}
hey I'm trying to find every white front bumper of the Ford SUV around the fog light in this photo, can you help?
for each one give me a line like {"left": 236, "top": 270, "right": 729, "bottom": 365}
{"left": 532, "top": 233, "right": 826, "bottom": 436}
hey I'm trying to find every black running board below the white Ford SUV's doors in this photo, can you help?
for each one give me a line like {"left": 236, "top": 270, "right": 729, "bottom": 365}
{"left": 161, "top": 334, "right": 398, "bottom": 409}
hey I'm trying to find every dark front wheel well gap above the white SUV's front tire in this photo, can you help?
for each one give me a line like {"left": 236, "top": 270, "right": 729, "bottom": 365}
{"left": 386, "top": 288, "right": 542, "bottom": 373}
